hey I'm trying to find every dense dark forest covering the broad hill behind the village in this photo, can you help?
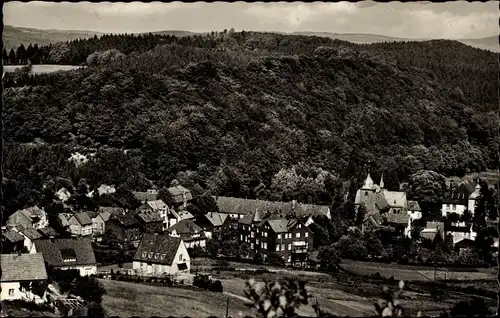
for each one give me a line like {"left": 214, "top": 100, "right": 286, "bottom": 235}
{"left": 3, "top": 30, "right": 499, "bottom": 219}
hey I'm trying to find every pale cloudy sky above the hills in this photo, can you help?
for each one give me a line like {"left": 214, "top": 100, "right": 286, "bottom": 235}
{"left": 3, "top": 1, "right": 499, "bottom": 39}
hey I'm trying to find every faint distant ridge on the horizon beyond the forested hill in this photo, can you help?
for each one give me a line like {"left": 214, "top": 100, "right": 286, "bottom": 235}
{"left": 3, "top": 25, "right": 500, "bottom": 52}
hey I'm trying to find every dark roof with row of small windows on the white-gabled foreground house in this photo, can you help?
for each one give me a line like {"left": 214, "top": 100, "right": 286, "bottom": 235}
{"left": 134, "top": 234, "right": 182, "bottom": 265}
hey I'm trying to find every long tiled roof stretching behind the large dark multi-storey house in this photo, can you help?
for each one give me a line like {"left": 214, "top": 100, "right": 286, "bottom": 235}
{"left": 214, "top": 197, "right": 329, "bottom": 217}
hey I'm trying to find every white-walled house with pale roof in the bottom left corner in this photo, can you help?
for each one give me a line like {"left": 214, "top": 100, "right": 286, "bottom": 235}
{"left": 0, "top": 253, "right": 47, "bottom": 304}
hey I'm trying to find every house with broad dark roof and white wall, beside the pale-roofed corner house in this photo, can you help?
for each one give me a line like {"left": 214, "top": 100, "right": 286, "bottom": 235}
{"left": 35, "top": 237, "right": 97, "bottom": 276}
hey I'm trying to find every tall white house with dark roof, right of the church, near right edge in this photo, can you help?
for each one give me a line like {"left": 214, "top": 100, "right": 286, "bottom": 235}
{"left": 441, "top": 181, "right": 481, "bottom": 217}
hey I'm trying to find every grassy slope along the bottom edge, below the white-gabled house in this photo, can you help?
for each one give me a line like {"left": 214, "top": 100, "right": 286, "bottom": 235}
{"left": 100, "top": 280, "right": 249, "bottom": 317}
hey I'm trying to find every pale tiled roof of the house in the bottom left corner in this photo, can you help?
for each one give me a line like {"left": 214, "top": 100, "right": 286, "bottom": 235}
{"left": 0, "top": 253, "right": 47, "bottom": 282}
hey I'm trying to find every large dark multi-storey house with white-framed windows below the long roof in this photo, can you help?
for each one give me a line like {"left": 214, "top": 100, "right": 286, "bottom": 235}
{"left": 257, "top": 219, "right": 314, "bottom": 267}
